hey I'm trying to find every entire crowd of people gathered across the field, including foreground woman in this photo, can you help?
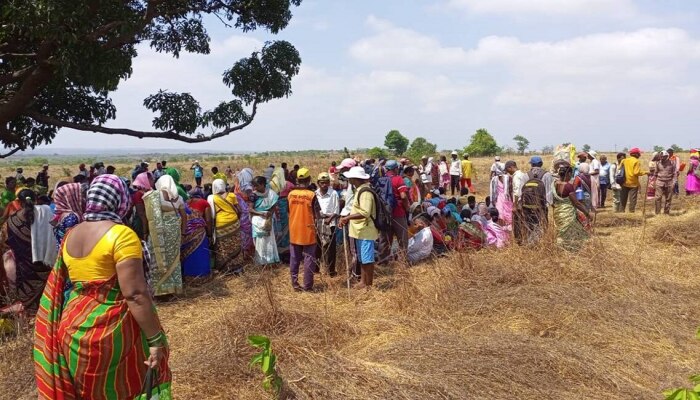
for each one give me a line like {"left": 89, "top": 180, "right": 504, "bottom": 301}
{"left": 0, "top": 148, "right": 700, "bottom": 399}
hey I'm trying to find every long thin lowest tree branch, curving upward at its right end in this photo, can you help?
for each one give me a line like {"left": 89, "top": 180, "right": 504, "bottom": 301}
{"left": 25, "top": 101, "right": 258, "bottom": 143}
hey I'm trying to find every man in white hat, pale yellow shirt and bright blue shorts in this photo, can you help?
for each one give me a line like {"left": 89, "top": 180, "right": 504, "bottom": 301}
{"left": 340, "top": 167, "right": 379, "bottom": 288}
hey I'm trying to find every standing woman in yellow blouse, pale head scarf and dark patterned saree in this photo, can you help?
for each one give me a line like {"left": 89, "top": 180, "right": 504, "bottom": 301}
{"left": 208, "top": 179, "right": 243, "bottom": 274}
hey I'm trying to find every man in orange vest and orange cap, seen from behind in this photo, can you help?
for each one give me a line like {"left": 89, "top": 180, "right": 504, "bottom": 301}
{"left": 287, "top": 168, "right": 320, "bottom": 292}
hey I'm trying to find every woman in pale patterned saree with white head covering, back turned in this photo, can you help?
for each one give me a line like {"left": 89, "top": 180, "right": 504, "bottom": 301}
{"left": 143, "top": 175, "right": 187, "bottom": 296}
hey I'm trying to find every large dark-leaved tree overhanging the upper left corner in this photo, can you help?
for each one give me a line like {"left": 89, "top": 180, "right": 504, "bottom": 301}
{"left": 0, "top": 0, "right": 301, "bottom": 156}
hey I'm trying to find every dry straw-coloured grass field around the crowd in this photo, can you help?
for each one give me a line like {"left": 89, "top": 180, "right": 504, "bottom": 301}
{"left": 0, "top": 152, "right": 700, "bottom": 400}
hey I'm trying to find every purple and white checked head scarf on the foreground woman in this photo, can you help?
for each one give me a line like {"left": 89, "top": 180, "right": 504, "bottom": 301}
{"left": 83, "top": 174, "right": 131, "bottom": 224}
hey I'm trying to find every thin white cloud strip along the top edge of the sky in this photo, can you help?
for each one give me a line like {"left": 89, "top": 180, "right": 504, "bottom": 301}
{"left": 447, "top": 0, "right": 637, "bottom": 18}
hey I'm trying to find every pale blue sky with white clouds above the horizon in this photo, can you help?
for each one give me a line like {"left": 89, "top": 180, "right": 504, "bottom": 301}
{"left": 42, "top": 0, "right": 700, "bottom": 152}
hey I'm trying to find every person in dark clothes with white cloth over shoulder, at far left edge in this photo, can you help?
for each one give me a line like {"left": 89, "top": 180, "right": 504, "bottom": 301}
{"left": 0, "top": 189, "right": 57, "bottom": 316}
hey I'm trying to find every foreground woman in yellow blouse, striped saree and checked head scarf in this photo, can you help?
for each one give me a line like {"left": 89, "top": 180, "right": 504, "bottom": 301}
{"left": 34, "top": 175, "right": 171, "bottom": 399}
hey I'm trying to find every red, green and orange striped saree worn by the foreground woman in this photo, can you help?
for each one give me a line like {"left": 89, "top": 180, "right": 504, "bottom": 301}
{"left": 34, "top": 253, "right": 172, "bottom": 400}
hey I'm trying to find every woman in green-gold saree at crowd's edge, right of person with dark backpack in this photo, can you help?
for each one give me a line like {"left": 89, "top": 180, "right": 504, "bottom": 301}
{"left": 553, "top": 164, "right": 590, "bottom": 251}
